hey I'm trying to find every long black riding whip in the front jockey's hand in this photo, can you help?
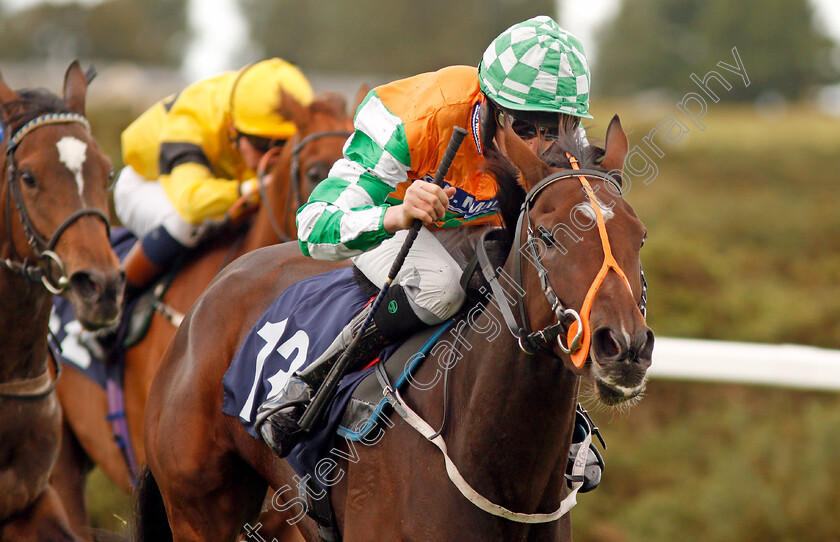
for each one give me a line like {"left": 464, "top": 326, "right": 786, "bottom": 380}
{"left": 298, "top": 126, "right": 467, "bottom": 431}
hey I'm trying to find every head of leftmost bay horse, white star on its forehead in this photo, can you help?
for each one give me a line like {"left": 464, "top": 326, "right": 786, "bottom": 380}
{"left": 0, "top": 62, "right": 125, "bottom": 329}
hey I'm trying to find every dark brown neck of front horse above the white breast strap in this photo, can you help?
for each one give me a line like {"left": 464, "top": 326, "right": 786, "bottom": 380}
{"left": 445, "top": 280, "right": 578, "bottom": 512}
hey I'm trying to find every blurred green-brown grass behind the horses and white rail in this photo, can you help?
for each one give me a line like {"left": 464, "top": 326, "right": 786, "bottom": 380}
{"left": 80, "top": 101, "right": 840, "bottom": 542}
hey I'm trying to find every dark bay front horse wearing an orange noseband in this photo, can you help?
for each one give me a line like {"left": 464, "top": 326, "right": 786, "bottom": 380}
{"left": 138, "top": 117, "right": 653, "bottom": 542}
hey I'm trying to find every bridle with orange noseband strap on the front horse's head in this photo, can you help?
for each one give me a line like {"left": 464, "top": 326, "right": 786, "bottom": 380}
{"left": 478, "top": 153, "right": 647, "bottom": 368}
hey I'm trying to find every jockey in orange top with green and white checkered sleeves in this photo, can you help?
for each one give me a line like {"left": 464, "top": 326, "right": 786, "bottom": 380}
{"left": 257, "top": 16, "right": 592, "bottom": 457}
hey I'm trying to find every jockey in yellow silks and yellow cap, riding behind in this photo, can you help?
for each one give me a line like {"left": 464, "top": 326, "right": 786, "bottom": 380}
{"left": 114, "top": 58, "right": 312, "bottom": 291}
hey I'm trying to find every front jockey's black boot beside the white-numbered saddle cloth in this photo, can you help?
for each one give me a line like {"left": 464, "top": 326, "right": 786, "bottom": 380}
{"left": 254, "top": 284, "right": 426, "bottom": 457}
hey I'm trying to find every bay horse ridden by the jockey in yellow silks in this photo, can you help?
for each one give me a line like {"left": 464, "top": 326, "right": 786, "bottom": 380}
{"left": 53, "top": 89, "right": 352, "bottom": 540}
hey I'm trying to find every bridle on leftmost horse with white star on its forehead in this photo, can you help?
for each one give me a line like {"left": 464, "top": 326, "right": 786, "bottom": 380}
{"left": 0, "top": 113, "right": 110, "bottom": 294}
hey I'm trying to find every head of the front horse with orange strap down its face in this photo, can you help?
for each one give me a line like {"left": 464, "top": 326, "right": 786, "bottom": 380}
{"left": 505, "top": 116, "right": 654, "bottom": 404}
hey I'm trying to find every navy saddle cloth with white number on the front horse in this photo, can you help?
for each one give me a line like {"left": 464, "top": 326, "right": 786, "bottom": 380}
{"left": 222, "top": 267, "right": 442, "bottom": 488}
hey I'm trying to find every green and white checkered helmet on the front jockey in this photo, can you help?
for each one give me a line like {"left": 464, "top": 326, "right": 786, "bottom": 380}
{"left": 478, "top": 15, "right": 592, "bottom": 119}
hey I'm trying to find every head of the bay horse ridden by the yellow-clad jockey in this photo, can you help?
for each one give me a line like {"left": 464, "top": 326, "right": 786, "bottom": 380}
{"left": 266, "top": 91, "right": 353, "bottom": 239}
